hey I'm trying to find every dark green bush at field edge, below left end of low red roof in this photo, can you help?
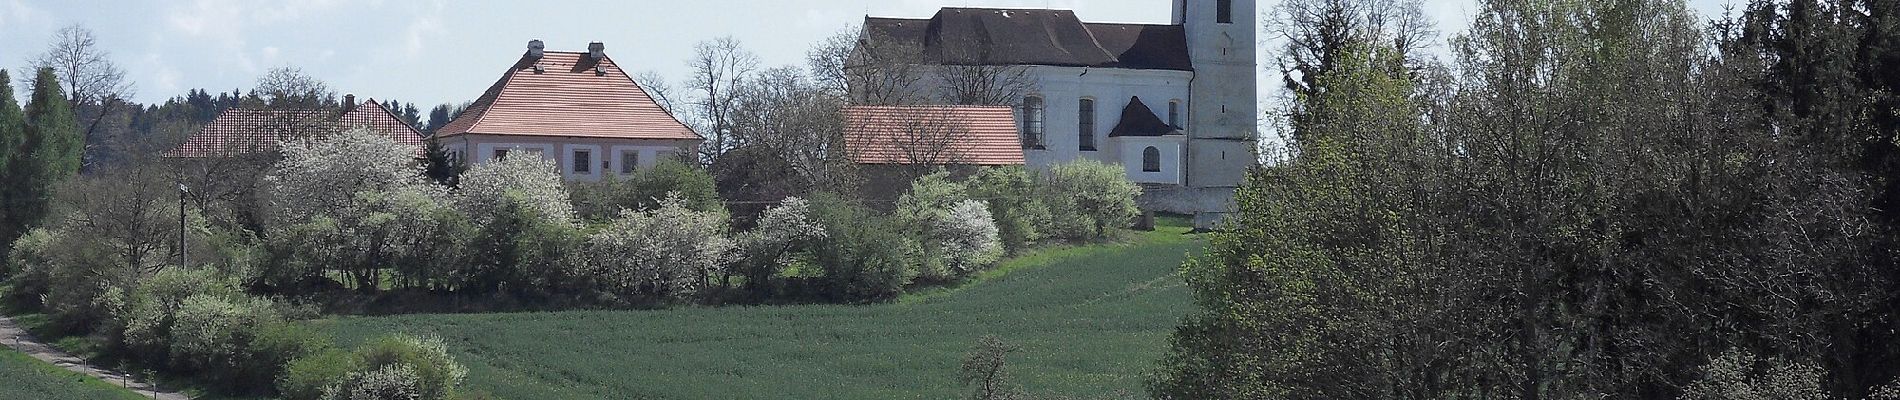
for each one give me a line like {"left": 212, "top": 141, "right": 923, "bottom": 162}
{"left": 811, "top": 195, "right": 922, "bottom": 301}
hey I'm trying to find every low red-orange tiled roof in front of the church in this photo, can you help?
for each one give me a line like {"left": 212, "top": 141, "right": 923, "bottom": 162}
{"left": 844, "top": 106, "right": 1022, "bottom": 165}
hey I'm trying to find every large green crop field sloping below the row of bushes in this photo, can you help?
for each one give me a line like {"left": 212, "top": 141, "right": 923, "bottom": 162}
{"left": 317, "top": 226, "right": 1201, "bottom": 398}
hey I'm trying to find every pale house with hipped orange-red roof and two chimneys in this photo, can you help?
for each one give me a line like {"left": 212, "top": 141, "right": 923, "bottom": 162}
{"left": 437, "top": 40, "right": 703, "bottom": 180}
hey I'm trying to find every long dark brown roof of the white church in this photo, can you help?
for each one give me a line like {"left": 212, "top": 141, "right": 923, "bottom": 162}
{"left": 865, "top": 8, "right": 1193, "bottom": 70}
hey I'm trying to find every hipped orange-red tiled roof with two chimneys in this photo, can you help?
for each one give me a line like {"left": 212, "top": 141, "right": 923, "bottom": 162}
{"left": 439, "top": 51, "right": 699, "bottom": 140}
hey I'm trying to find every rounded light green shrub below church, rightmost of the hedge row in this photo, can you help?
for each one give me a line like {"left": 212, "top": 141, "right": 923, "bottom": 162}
{"left": 1041, "top": 159, "right": 1142, "bottom": 241}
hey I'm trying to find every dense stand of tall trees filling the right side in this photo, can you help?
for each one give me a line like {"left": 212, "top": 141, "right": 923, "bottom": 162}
{"left": 1150, "top": 0, "right": 1900, "bottom": 398}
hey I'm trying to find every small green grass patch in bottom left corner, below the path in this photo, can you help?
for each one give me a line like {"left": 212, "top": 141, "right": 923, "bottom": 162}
{"left": 0, "top": 347, "right": 143, "bottom": 400}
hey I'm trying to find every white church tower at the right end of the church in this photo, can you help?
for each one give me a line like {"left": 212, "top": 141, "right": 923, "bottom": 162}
{"left": 1174, "top": 0, "right": 1260, "bottom": 220}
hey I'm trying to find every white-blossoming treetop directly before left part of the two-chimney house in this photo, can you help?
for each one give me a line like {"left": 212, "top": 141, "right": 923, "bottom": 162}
{"left": 458, "top": 157, "right": 574, "bottom": 226}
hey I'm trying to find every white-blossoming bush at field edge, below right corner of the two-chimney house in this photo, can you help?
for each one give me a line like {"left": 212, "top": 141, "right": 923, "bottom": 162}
{"left": 583, "top": 193, "right": 733, "bottom": 300}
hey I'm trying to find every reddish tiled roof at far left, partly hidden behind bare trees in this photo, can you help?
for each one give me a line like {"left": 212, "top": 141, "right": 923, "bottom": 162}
{"left": 163, "top": 100, "right": 424, "bottom": 157}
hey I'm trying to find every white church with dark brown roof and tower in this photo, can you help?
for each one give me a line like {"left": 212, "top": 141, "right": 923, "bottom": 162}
{"left": 847, "top": 0, "right": 1258, "bottom": 227}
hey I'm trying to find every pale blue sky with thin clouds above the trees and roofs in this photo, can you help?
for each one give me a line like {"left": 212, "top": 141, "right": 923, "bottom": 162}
{"left": 0, "top": 0, "right": 1735, "bottom": 112}
